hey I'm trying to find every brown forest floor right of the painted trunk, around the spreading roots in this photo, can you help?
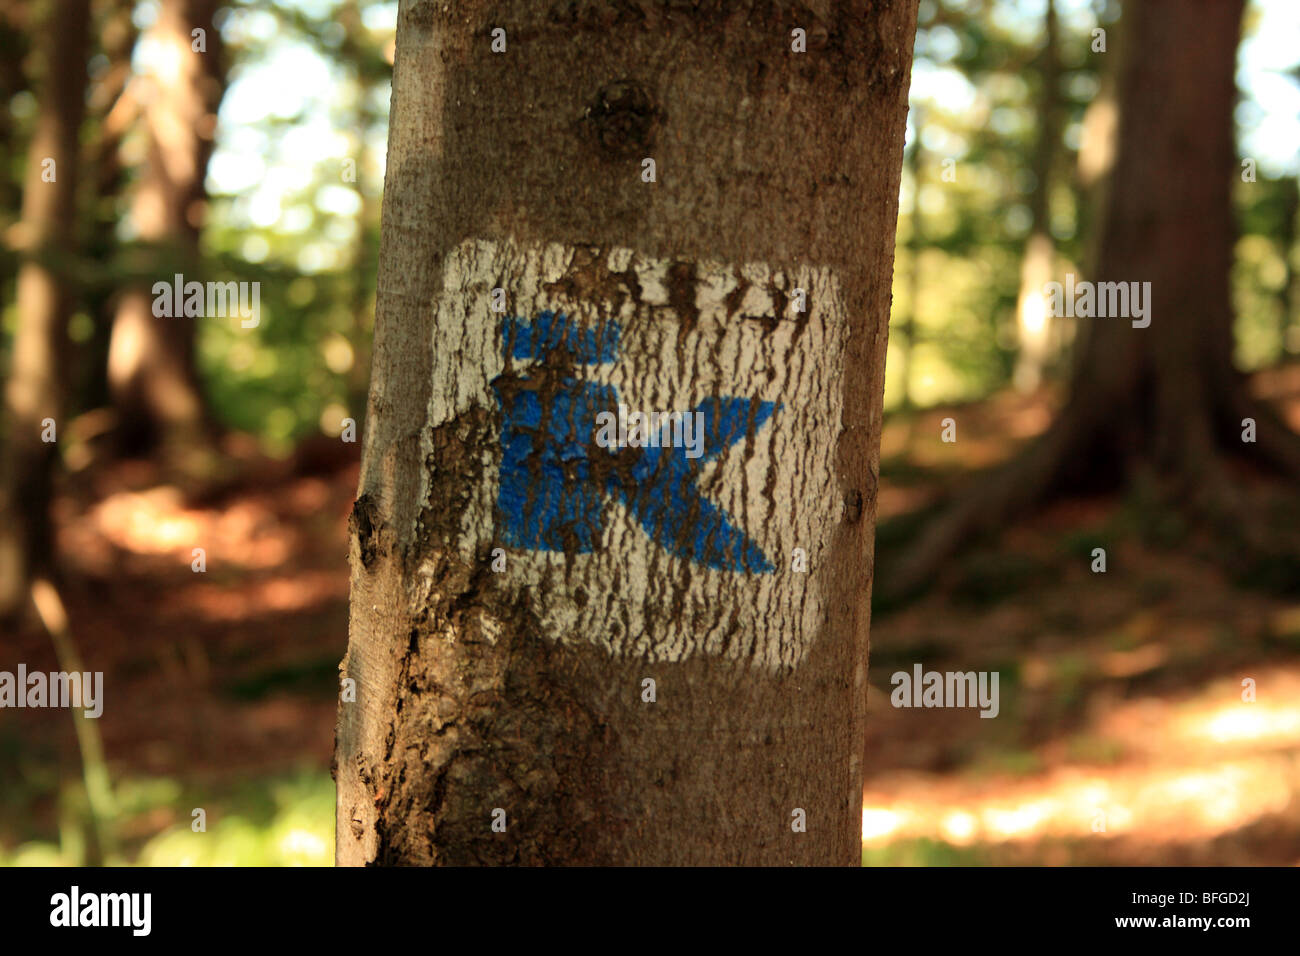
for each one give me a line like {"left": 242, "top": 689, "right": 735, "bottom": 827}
{"left": 863, "top": 368, "right": 1300, "bottom": 865}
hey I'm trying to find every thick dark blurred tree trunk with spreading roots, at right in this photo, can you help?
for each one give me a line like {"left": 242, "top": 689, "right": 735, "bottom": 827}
{"left": 889, "top": 0, "right": 1300, "bottom": 593}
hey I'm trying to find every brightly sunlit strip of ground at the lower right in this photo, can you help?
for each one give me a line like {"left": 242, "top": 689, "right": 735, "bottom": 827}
{"left": 862, "top": 665, "right": 1300, "bottom": 847}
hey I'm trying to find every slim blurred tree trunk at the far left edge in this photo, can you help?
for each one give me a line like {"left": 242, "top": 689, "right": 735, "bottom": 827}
{"left": 0, "top": 0, "right": 90, "bottom": 617}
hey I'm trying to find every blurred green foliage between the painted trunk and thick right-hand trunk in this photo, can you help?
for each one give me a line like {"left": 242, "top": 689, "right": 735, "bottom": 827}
{"left": 885, "top": 0, "right": 1099, "bottom": 408}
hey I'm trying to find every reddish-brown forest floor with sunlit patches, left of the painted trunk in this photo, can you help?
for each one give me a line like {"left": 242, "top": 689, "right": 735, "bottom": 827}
{"left": 0, "top": 466, "right": 356, "bottom": 866}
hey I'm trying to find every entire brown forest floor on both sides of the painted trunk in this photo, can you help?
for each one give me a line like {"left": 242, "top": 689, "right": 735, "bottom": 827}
{"left": 0, "top": 369, "right": 1300, "bottom": 865}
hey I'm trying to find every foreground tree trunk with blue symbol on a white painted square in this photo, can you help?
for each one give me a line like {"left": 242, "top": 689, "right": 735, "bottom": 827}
{"left": 335, "top": 0, "right": 915, "bottom": 865}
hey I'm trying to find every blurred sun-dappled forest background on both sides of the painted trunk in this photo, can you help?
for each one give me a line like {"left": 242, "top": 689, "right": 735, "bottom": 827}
{"left": 0, "top": 0, "right": 1300, "bottom": 865}
